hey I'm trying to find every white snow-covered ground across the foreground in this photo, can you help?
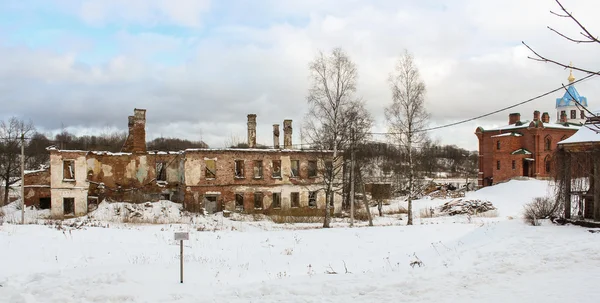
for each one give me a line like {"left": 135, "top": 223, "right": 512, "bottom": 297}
{"left": 0, "top": 180, "right": 600, "bottom": 303}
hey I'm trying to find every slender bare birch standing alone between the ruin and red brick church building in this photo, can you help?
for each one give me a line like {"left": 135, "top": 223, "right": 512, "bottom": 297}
{"left": 385, "top": 50, "right": 429, "bottom": 225}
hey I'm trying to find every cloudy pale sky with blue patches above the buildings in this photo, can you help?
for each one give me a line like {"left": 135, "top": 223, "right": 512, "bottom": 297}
{"left": 0, "top": 0, "right": 600, "bottom": 150}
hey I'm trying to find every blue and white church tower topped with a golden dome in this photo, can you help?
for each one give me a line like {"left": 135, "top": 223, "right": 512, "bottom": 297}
{"left": 556, "top": 69, "right": 588, "bottom": 124}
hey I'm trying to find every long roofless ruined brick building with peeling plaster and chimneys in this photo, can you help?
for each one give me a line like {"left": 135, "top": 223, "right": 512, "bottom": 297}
{"left": 25, "top": 109, "right": 342, "bottom": 216}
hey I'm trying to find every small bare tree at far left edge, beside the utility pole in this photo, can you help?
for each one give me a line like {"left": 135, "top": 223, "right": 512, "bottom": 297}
{"left": 0, "top": 117, "right": 35, "bottom": 205}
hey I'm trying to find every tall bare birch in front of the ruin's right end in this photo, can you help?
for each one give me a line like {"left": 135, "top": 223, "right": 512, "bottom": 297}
{"left": 302, "top": 48, "right": 364, "bottom": 228}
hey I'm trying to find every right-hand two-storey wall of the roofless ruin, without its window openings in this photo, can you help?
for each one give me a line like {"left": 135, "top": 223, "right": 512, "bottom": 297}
{"left": 184, "top": 149, "right": 341, "bottom": 213}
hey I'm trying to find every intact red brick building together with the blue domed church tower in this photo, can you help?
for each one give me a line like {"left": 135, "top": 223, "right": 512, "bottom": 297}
{"left": 475, "top": 72, "right": 587, "bottom": 187}
